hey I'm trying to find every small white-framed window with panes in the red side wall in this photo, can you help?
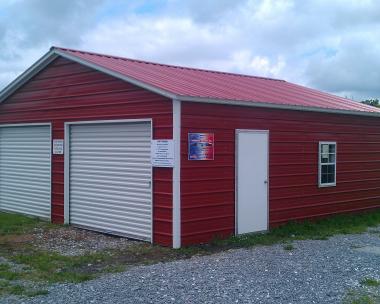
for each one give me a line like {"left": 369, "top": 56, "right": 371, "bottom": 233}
{"left": 319, "top": 141, "right": 336, "bottom": 187}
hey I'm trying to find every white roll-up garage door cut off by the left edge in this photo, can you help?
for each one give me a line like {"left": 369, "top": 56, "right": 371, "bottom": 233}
{"left": 0, "top": 125, "right": 51, "bottom": 218}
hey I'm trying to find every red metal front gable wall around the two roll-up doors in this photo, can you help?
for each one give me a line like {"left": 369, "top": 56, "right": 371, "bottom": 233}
{"left": 0, "top": 58, "right": 173, "bottom": 245}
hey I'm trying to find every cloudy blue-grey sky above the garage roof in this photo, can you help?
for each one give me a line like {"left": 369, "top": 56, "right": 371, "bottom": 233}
{"left": 0, "top": 0, "right": 380, "bottom": 100}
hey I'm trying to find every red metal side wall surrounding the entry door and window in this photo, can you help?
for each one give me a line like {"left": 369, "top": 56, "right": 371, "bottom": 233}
{"left": 181, "top": 103, "right": 380, "bottom": 245}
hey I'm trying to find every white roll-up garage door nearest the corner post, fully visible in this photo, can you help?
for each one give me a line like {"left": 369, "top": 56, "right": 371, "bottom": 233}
{"left": 69, "top": 122, "right": 152, "bottom": 240}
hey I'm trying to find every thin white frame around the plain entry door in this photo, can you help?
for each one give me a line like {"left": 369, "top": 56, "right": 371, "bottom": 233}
{"left": 235, "top": 129, "right": 270, "bottom": 235}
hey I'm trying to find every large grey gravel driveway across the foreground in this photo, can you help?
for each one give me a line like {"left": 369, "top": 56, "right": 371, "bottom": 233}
{"left": 5, "top": 229, "right": 380, "bottom": 304}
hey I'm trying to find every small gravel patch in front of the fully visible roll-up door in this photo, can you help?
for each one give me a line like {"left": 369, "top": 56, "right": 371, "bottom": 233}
{"left": 30, "top": 226, "right": 139, "bottom": 256}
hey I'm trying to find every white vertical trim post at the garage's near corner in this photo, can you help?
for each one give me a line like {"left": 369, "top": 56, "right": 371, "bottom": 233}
{"left": 173, "top": 99, "right": 181, "bottom": 248}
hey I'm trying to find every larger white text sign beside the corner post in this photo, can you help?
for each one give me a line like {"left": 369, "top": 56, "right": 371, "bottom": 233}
{"left": 151, "top": 139, "right": 174, "bottom": 168}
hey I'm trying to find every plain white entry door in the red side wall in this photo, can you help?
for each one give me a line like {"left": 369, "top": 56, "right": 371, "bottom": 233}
{"left": 236, "top": 130, "right": 269, "bottom": 234}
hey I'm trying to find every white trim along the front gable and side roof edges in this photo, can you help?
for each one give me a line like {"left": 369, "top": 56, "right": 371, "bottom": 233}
{"left": 0, "top": 47, "right": 380, "bottom": 117}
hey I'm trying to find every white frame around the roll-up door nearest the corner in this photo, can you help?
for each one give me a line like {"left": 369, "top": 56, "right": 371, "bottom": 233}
{"left": 63, "top": 118, "right": 153, "bottom": 243}
